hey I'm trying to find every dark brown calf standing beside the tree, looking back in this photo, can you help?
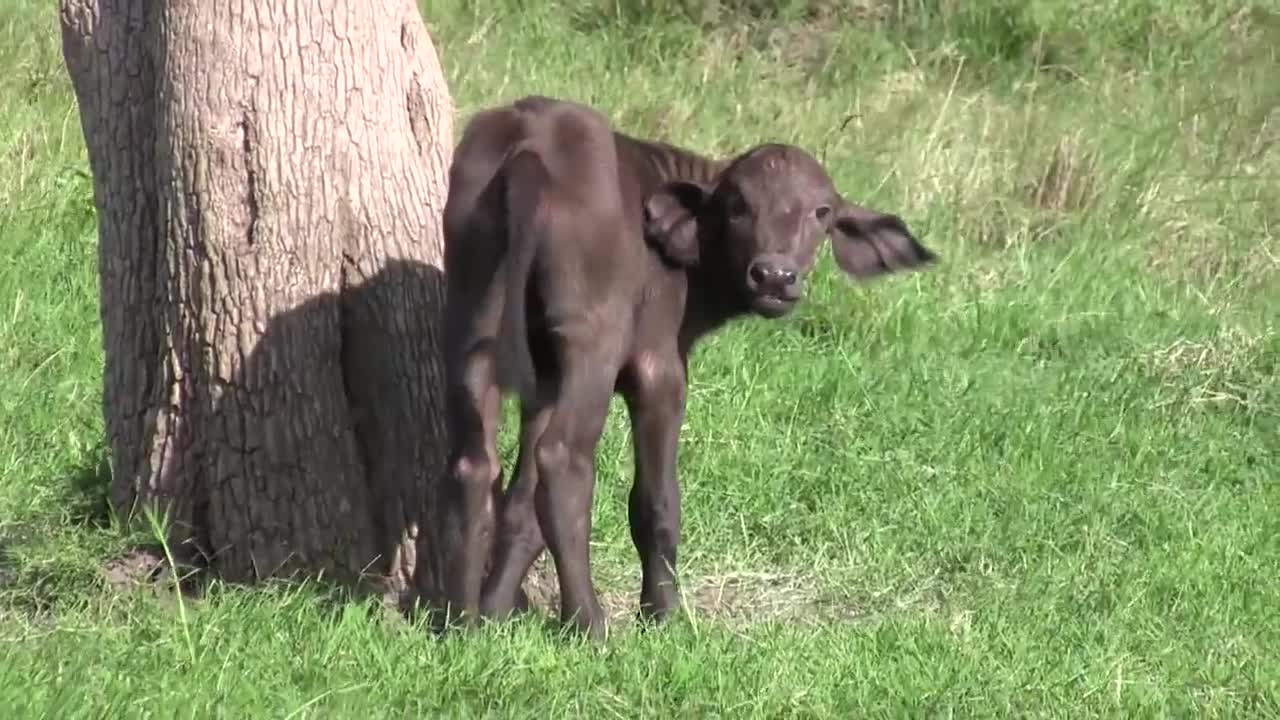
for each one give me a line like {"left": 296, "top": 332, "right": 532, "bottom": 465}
{"left": 444, "top": 96, "right": 934, "bottom": 638}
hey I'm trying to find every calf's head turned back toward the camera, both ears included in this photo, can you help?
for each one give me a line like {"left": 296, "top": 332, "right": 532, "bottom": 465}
{"left": 644, "top": 143, "right": 937, "bottom": 318}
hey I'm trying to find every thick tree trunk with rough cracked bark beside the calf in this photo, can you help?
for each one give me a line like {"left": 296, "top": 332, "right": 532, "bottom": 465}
{"left": 60, "top": 0, "right": 453, "bottom": 598}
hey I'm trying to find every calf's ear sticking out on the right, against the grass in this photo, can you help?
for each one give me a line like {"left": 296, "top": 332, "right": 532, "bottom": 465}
{"left": 828, "top": 200, "right": 938, "bottom": 279}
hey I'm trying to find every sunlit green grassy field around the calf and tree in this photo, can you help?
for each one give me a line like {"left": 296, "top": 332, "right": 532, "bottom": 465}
{"left": 0, "top": 0, "right": 1280, "bottom": 719}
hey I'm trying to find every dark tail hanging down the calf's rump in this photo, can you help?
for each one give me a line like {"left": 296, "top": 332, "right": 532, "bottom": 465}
{"left": 498, "top": 150, "right": 550, "bottom": 404}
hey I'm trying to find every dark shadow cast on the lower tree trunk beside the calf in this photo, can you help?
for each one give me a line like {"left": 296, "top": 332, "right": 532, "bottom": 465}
{"left": 90, "top": 260, "right": 447, "bottom": 620}
